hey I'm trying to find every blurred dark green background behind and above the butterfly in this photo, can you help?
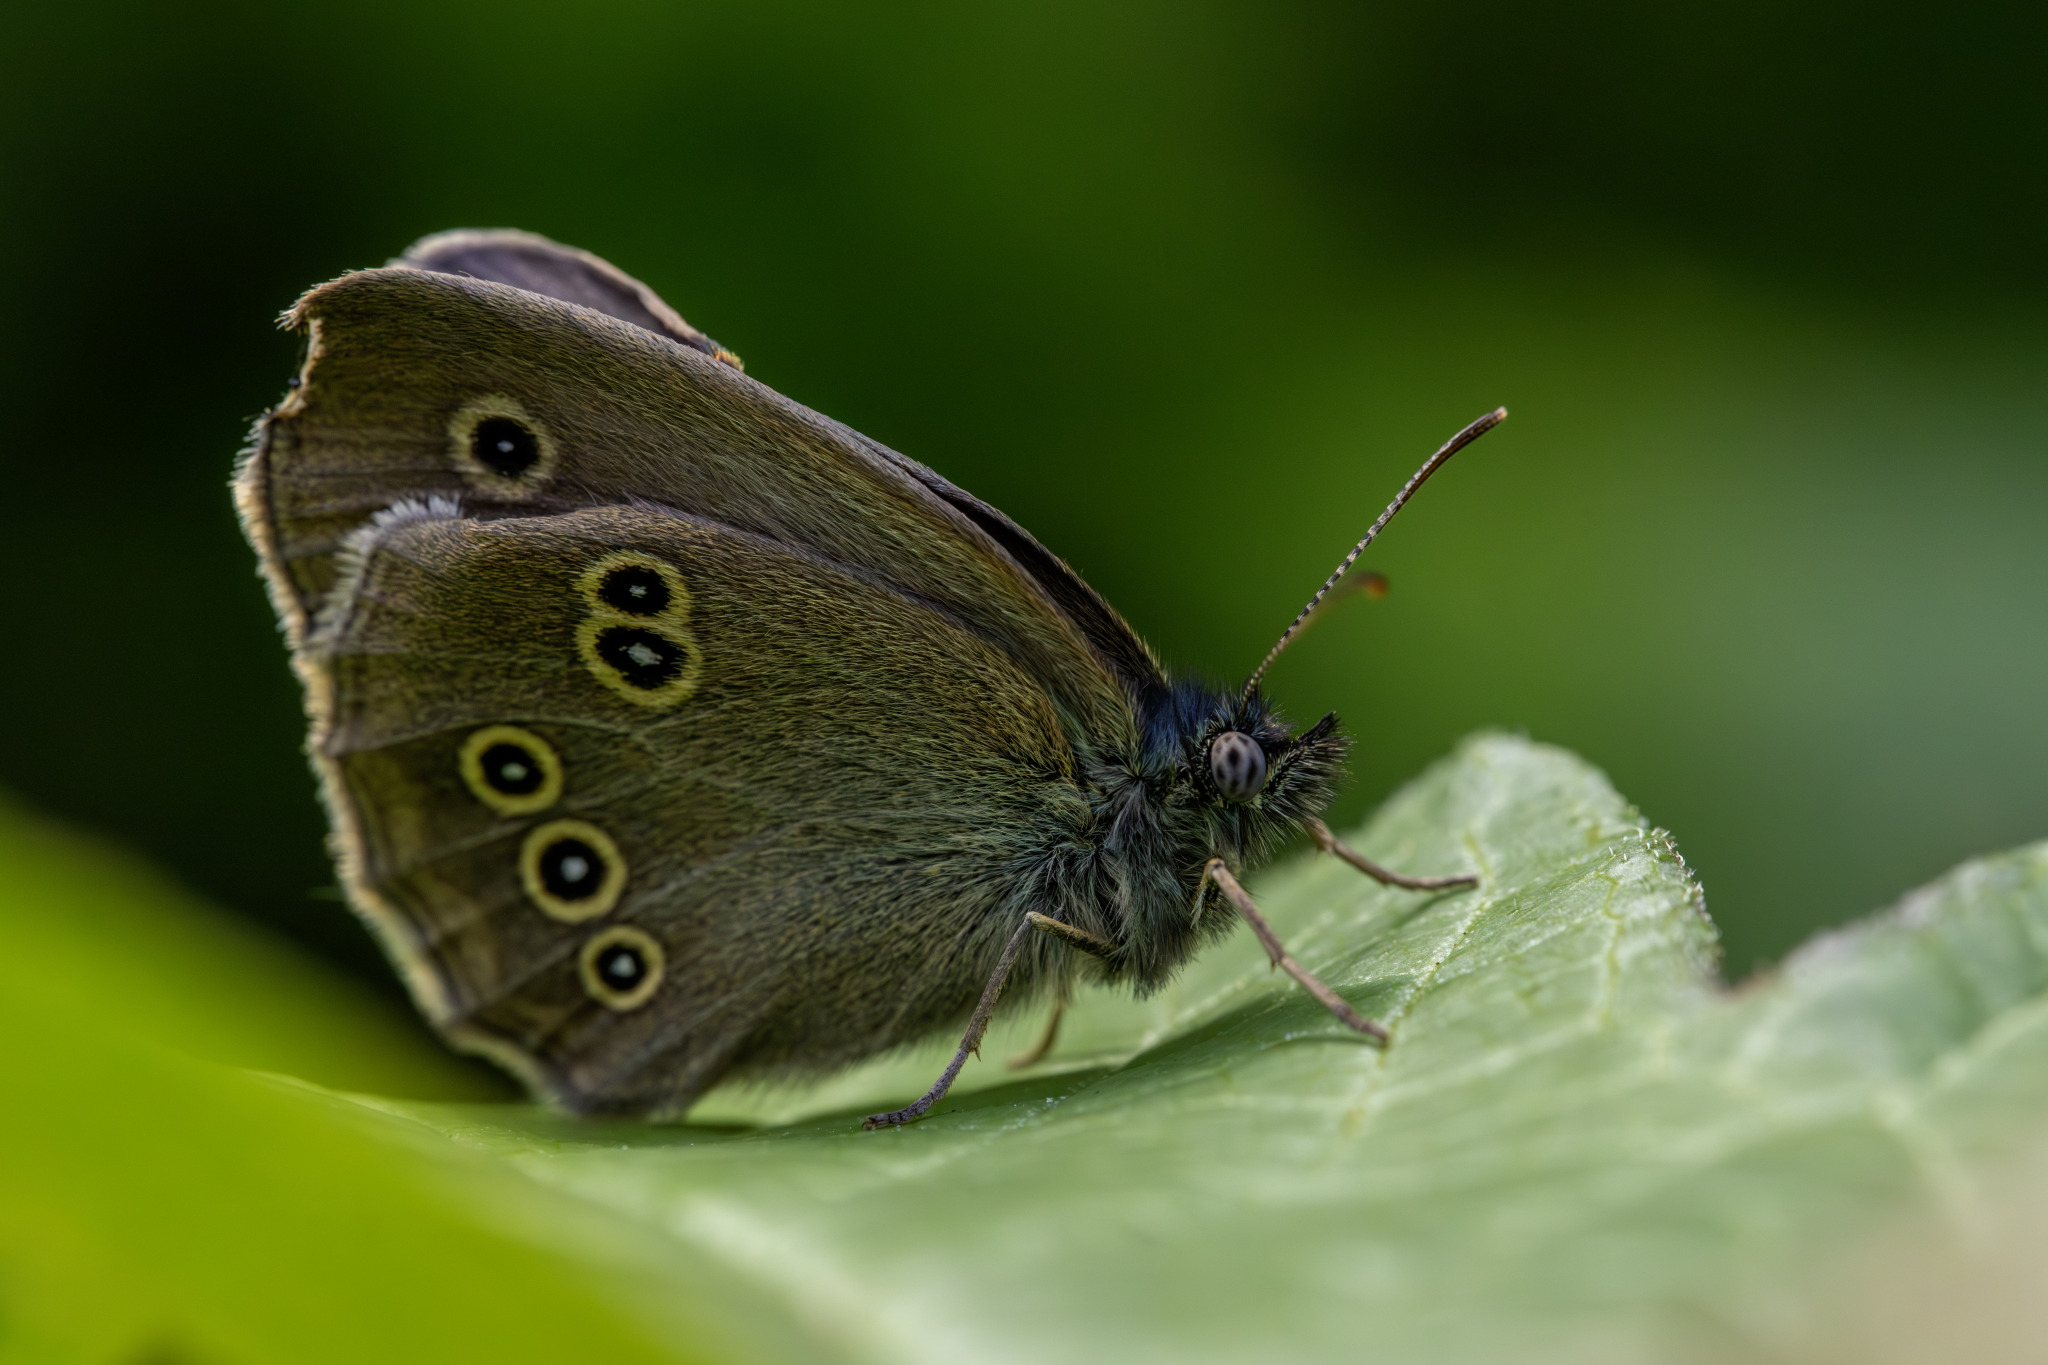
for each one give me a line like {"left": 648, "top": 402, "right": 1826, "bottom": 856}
{"left": 0, "top": 0, "right": 2048, "bottom": 1019}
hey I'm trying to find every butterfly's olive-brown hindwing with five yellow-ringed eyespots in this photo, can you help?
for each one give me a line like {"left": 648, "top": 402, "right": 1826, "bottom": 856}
{"left": 297, "top": 503, "right": 1087, "bottom": 1113}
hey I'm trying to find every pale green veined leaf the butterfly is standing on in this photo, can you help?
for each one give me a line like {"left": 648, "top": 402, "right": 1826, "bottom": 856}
{"left": 385, "top": 737, "right": 2048, "bottom": 1361}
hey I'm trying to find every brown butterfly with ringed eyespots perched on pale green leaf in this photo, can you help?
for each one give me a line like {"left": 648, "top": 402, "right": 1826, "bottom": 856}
{"left": 236, "top": 231, "right": 1505, "bottom": 1128}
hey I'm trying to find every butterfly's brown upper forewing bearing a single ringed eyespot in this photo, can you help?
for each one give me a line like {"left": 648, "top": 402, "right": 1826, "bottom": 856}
{"left": 240, "top": 259, "right": 1159, "bottom": 745}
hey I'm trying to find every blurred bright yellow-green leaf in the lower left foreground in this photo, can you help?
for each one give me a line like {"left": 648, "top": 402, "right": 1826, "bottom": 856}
{"left": 0, "top": 804, "right": 715, "bottom": 1365}
